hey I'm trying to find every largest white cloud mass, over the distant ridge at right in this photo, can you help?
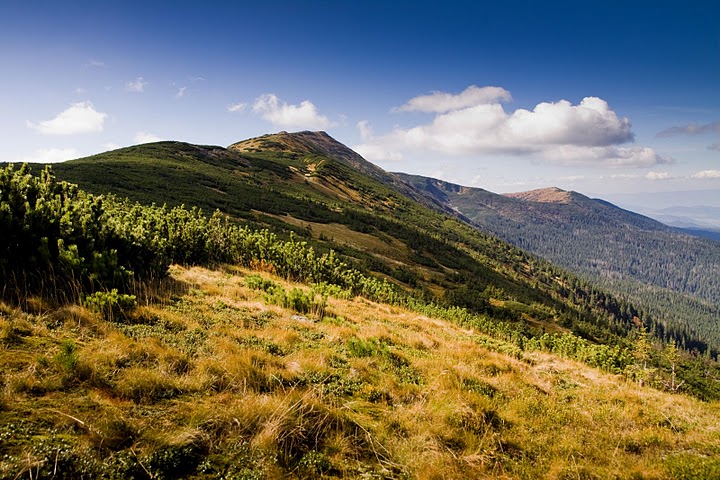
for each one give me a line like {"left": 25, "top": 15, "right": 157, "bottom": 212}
{"left": 353, "top": 86, "right": 672, "bottom": 167}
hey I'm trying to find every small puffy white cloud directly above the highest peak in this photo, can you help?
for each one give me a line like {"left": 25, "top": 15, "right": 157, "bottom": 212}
{"left": 253, "top": 93, "right": 334, "bottom": 130}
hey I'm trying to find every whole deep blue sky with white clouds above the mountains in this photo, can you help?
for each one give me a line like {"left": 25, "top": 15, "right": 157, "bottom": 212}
{"left": 0, "top": 0, "right": 720, "bottom": 206}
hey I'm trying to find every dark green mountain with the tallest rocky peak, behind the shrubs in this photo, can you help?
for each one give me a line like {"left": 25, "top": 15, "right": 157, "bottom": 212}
{"left": 22, "top": 132, "right": 653, "bottom": 352}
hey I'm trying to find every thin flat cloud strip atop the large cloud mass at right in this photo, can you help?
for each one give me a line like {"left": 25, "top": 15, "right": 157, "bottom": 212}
{"left": 395, "top": 85, "right": 512, "bottom": 113}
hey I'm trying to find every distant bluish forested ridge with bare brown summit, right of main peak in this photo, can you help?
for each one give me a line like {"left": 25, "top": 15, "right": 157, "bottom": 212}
{"left": 399, "top": 174, "right": 720, "bottom": 348}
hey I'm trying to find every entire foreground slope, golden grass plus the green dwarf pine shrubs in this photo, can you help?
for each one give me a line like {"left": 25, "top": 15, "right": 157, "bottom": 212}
{"left": 0, "top": 146, "right": 720, "bottom": 479}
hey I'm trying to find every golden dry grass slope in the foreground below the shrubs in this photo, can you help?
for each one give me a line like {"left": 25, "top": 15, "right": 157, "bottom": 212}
{"left": 0, "top": 267, "right": 720, "bottom": 479}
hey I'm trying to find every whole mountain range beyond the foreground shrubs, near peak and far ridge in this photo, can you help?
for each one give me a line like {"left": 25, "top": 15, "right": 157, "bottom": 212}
{"left": 12, "top": 132, "right": 720, "bottom": 350}
